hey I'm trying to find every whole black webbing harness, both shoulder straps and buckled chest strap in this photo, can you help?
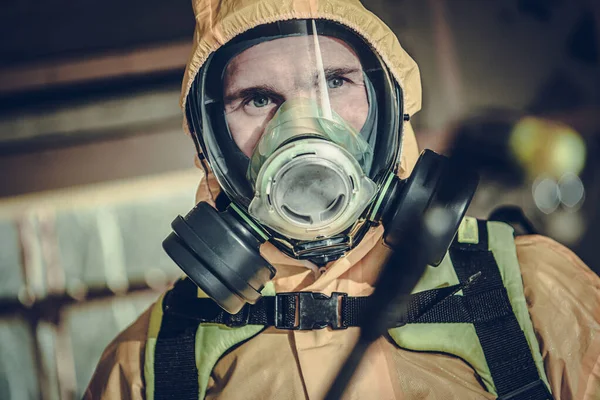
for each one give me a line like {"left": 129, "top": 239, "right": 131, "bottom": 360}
{"left": 154, "top": 221, "right": 552, "bottom": 400}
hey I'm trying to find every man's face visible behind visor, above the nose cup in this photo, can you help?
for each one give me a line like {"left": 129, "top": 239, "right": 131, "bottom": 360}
{"left": 224, "top": 36, "right": 369, "bottom": 157}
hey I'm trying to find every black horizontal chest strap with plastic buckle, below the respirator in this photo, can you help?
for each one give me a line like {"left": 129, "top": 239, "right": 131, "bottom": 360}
{"left": 164, "top": 279, "right": 471, "bottom": 330}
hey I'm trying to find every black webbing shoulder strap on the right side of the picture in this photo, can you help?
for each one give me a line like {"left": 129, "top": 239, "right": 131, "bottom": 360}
{"left": 450, "top": 221, "right": 552, "bottom": 400}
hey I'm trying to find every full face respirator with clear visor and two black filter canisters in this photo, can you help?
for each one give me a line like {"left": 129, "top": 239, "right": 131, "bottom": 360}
{"left": 163, "top": 20, "right": 478, "bottom": 314}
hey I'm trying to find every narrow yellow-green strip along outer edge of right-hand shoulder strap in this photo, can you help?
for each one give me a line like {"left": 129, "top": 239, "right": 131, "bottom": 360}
{"left": 487, "top": 221, "right": 550, "bottom": 390}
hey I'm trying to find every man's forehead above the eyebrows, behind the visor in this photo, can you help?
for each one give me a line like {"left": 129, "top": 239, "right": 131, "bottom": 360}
{"left": 225, "top": 36, "right": 360, "bottom": 80}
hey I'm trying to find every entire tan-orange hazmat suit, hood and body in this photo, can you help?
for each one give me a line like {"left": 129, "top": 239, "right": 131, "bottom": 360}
{"left": 85, "top": 0, "right": 600, "bottom": 400}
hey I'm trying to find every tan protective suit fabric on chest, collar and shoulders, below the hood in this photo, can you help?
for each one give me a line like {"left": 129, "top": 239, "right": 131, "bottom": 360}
{"left": 85, "top": 227, "right": 600, "bottom": 400}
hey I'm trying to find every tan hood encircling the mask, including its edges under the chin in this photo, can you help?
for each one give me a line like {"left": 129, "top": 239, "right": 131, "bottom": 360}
{"left": 181, "top": 0, "right": 421, "bottom": 274}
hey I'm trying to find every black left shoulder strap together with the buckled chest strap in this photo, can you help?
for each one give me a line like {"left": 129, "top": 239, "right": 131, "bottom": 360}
{"left": 154, "top": 279, "right": 470, "bottom": 400}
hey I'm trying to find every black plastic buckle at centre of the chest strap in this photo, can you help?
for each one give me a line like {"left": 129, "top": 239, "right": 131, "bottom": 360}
{"left": 275, "top": 292, "right": 346, "bottom": 330}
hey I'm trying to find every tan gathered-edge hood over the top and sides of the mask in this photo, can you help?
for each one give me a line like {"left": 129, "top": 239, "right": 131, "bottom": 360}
{"left": 181, "top": 0, "right": 421, "bottom": 175}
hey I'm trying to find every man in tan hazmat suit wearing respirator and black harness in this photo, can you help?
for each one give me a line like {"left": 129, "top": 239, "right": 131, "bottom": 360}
{"left": 86, "top": 0, "right": 600, "bottom": 399}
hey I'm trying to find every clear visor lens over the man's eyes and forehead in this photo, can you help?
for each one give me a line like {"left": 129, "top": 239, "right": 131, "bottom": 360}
{"left": 223, "top": 21, "right": 374, "bottom": 171}
